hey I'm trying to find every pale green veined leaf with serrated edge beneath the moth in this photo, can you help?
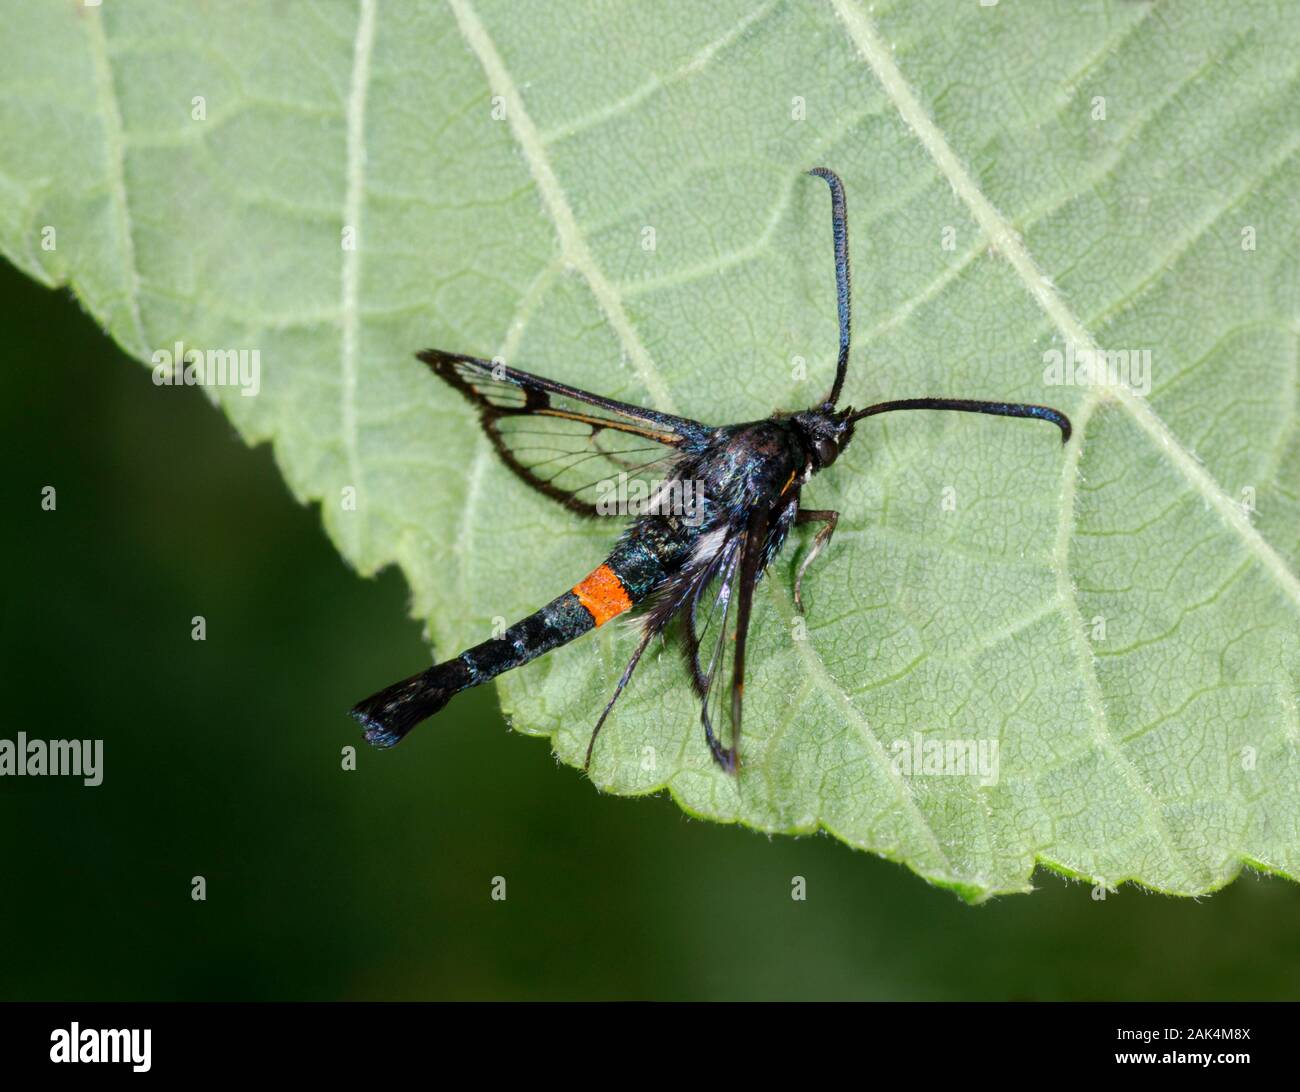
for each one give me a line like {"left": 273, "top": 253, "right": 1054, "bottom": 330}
{"left": 0, "top": 0, "right": 1300, "bottom": 898}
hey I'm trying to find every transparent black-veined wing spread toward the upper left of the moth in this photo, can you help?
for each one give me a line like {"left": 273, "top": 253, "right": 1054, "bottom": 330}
{"left": 420, "top": 350, "right": 709, "bottom": 515}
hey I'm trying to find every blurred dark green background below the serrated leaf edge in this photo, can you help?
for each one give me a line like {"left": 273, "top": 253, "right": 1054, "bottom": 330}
{"left": 0, "top": 267, "right": 1300, "bottom": 998}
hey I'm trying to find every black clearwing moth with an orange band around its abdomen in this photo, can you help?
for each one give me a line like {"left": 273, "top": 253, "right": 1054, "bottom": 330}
{"left": 351, "top": 168, "right": 1070, "bottom": 774}
